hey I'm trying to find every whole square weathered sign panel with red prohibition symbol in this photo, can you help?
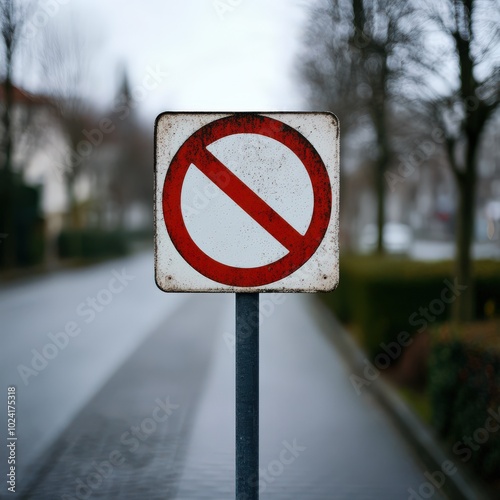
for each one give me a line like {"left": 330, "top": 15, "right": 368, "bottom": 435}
{"left": 155, "top": 113, "right": 339, "bottom": 292}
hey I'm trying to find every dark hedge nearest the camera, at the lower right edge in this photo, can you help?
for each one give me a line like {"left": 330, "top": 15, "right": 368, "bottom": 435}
{"left": 428, "top": 339, "right": 500, "bottom": 479}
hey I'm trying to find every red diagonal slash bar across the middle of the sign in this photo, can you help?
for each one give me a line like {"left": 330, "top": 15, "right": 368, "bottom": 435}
{"left": 193, "top": 148, "right": 303, "bottom": 251}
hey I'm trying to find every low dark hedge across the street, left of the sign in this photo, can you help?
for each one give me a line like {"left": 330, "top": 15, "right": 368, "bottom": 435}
{"left": 58, "top": 229, "right": 127, "bottom": 259}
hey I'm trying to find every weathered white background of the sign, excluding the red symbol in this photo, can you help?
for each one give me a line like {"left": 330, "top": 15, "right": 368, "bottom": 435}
{"left": 155, "top": 113, "right": 339, "bottom": 292}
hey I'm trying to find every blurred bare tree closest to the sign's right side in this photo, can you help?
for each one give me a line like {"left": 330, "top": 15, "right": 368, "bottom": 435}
{"left": 301, "top": 0, "right": 408, "bottom": 253}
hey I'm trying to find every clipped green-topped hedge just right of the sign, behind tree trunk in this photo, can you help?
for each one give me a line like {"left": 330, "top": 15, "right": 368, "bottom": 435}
{"left": 324, "top": 256, "right": 500, "bottom": 356}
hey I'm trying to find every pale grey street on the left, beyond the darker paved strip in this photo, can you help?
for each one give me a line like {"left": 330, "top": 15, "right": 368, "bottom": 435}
{"left": 0, "top": 253, "right": 183, "bottom": 484}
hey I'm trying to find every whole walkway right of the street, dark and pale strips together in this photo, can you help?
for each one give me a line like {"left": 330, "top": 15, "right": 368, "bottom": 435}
{"left": 21, "top": 294, "right": 443, "bottom": 500}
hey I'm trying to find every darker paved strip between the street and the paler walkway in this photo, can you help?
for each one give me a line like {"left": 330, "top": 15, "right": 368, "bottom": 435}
{"left": 21, "top": 294, "right": 224, "bottom": 500}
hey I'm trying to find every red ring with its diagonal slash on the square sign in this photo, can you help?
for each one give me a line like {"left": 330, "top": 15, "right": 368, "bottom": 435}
{"left": 162, "top": 114, "right": 332, "bottom": 287}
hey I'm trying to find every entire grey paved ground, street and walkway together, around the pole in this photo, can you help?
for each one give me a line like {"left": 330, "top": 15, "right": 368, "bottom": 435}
{"left": 0, "top": 254, "right": 441, "bottom": 500}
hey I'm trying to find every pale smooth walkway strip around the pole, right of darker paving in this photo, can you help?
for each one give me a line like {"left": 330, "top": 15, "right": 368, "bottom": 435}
{"left": 176, "top": 294, "right": 443, "bottom": 500}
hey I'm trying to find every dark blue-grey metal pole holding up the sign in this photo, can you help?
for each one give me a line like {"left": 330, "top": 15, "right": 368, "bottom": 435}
{"left": 236, "top": 293, "right": 259, "bottom": 500}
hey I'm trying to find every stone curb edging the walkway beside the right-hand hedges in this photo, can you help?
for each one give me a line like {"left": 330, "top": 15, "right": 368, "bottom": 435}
{"left": 311, "top": 299, "right": 495, "bottom": 500}
